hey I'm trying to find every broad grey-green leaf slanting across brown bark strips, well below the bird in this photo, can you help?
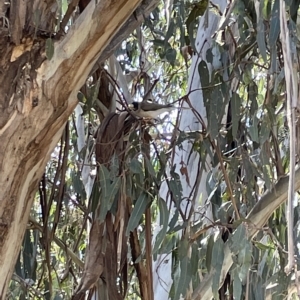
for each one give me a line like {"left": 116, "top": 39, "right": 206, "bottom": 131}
{"left": 126, "top": 192, "right": 150, "bottom": 236}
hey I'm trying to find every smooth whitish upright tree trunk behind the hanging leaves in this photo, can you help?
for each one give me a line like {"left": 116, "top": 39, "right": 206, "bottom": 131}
{"left": 153, "top": 0, "right": 227, "bottom": 300}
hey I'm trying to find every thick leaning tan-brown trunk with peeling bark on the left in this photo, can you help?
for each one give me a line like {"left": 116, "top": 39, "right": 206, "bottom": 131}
{"left": 0, "top": 0, "right": 144, "bottom": 299}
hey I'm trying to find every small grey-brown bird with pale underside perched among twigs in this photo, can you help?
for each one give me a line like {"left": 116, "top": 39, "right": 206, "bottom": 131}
{"left": 128, "top": 100, "right": 179, "bottom": 119}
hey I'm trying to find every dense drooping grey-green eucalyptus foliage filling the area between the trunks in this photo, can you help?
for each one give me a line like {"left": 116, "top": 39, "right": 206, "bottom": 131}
{"left": 8, "top": 0, "right": 299, "bottom": 299}
